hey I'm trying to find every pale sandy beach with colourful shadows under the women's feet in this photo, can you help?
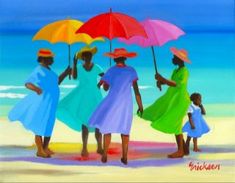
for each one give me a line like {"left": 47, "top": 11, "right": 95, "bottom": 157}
{"left": 0, "top": 117, "right": 235, "bottom": 182}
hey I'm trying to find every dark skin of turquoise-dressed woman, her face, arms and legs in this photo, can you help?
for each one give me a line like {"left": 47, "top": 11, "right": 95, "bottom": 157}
{"left": 72, "top": 52, "right": 103, "bottom": 157}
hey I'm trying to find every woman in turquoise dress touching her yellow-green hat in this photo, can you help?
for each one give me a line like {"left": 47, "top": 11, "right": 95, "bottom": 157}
{"left": 57, "top": 47, "right": 103, "bottom": 157}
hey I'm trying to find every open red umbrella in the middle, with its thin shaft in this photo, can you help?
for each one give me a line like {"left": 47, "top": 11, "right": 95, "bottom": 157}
{"left": 76, "top": 9, "right": 147, "bottom": 65}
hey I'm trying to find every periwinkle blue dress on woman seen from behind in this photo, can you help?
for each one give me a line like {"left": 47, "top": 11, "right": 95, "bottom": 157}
{"left": 89, "top": 66, "right": 138, "bottom": 135}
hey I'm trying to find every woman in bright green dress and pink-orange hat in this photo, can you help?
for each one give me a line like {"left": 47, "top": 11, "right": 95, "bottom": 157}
{"left": 142, "top": 48, "right": 190, "bottom": 158}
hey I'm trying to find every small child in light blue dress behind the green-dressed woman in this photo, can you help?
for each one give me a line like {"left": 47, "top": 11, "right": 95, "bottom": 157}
{"left": 182, "top": 93, "right": 210, "bottom": 152}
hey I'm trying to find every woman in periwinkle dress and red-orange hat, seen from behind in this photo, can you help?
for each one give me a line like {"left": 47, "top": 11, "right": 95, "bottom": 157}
{"left": 89, "top": 48, "right": 143, "bottom": 164}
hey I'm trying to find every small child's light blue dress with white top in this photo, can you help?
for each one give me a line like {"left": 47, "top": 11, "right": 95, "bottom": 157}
{"left": 182, "top": 104, "right": 210, "bottom": 138}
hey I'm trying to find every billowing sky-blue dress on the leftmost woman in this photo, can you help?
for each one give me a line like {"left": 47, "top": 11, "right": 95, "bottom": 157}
{"left": 8, "top": 66, "right": 60, "bottom": 137}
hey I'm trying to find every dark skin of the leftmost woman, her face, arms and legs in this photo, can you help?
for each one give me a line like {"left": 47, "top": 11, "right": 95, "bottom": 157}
{"left": 25, "top": 57, "right": 71, "bottom": 157}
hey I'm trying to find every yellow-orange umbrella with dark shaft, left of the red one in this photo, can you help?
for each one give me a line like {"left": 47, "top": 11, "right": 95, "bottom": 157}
{"left": 33, "top": 19, "right": 104, "bottom": 66}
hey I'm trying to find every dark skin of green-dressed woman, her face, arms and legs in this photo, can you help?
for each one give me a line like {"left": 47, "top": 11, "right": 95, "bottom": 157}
{"left": 155, "top": 55, "right": 189, "bottom": 158}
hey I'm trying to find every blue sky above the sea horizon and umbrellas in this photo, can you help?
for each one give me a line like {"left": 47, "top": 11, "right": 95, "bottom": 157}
{"left": 0, "top": 0, "right": 235, "bottom": 32}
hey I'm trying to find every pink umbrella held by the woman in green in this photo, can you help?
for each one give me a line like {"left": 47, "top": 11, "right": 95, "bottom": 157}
{"left": 118, "top": 19, "right": 185, "bottom": 73}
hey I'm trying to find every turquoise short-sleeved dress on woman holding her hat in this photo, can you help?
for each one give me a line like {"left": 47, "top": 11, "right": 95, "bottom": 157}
{"left": 57, "top": 64, "right": 103, "bottom": 131}
